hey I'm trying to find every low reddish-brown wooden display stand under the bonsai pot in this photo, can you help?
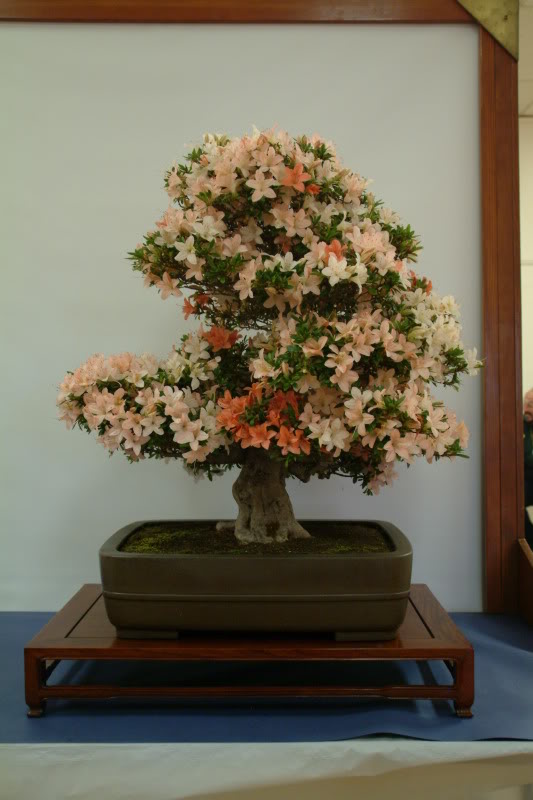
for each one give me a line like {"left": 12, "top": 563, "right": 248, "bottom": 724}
{"left": 24, "top": 584, "right": 474, "bottom": 717}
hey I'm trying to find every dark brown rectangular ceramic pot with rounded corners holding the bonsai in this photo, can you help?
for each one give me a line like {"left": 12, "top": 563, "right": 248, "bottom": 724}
{"left": 100, "top": 520, "right": 412, "bottom": 640}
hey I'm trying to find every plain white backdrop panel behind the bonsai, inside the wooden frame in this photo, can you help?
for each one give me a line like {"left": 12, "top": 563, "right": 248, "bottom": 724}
{"left": 0, "top": 24, "right": 482, "bottom": 610}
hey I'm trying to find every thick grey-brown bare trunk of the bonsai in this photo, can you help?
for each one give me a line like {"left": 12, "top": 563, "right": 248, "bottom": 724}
{"left": 217, "top": 449, "right": 309, "bottom": 543}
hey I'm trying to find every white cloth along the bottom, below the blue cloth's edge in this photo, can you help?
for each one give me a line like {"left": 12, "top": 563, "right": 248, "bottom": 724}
{"left": 0, "top": 744, "right": 533, "bottom": 800}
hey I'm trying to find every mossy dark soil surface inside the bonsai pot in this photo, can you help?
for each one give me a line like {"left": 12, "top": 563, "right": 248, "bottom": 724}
{"left": 120, "top": 521, "right": 394, "bottom": 556}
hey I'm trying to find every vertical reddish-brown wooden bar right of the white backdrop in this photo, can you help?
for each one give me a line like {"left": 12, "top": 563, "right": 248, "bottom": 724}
{"left": 480, "top": 28, "right": 524, "bottom": 612}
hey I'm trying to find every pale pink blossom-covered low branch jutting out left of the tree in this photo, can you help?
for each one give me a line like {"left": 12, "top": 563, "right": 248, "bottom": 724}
{"left": 58, "top": 335, "right": 228, "bottom": 463}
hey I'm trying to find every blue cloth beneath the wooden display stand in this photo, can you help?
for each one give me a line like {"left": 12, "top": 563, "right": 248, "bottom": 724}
{"left": 0, "top": 612, "right": 533, "bottom": 743}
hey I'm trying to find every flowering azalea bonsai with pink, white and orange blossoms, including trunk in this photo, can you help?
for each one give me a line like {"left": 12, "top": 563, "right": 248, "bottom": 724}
{"left": 57, "top": 129, "right": 480, "bottom": 542}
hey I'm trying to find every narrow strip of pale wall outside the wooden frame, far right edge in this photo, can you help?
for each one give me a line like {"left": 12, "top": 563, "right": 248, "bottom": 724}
{"left": 519, "top": 117, "right": 533, "bottom": 394}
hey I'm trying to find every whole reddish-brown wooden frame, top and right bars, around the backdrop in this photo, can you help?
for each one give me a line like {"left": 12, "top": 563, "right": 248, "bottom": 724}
{"left": 0, "top": 0, "right": 524, "bottom": 612}
